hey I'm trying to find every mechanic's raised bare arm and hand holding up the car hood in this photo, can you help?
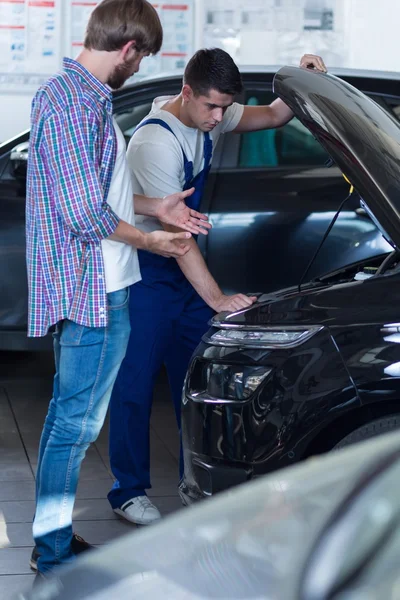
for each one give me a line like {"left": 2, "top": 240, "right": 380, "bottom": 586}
{"left": 234, "top": 54, "right": 326, "bottom": 133}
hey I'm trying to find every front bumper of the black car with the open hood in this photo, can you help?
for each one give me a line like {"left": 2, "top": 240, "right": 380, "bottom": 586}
{"left": 182, "top": 328, "right": 360, "bottom": 495}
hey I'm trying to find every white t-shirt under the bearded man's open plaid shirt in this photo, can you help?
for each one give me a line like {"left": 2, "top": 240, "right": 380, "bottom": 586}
{"left": 101, "top": 119, "right": 141, "bottom": 293}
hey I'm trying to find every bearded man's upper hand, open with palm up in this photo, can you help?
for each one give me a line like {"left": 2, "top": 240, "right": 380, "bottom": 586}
{"left": 157, "top": 188, "right": 211, "bottom": 235}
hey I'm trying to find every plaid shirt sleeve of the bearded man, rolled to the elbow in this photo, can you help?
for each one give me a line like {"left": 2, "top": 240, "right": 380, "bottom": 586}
{"left": 39, "top": 105, "right": 119, "bottom": 243}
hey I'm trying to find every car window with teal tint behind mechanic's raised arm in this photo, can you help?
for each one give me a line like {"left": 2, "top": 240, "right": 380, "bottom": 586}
{"left": 238, "top": 90, "right": 329, "bottom": 168}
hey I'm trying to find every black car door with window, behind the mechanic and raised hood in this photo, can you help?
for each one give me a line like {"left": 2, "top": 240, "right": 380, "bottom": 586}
{"left": 207, "top": 84, "right": 388, "bottom": 292}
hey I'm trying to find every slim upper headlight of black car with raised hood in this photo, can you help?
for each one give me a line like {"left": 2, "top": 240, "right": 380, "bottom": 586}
{"left": 205, "top": 325, "right": 322, "bottom": 348}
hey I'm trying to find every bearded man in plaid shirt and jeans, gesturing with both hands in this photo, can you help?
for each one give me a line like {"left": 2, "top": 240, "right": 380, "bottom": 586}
{"left": 26, "top": 0, "right": 208, "bottom": 576}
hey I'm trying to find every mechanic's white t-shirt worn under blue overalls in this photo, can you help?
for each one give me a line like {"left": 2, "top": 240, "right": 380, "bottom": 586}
{"left": 127, "top": 96, "right": 244, "bottom": 232}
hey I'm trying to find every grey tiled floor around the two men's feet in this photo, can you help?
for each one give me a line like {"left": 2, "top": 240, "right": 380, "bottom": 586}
{"left": 0, "top": 353, "right": 181, "bottom": 600}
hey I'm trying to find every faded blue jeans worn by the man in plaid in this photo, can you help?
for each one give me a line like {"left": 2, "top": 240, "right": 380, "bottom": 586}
{"left": 33, "top": 288, "right": 130, "bottom": 573}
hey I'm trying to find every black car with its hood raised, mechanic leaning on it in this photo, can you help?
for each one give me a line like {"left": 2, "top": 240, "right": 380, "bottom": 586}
{"left": 181, "top": 67, "right": 400, "bottom": 503}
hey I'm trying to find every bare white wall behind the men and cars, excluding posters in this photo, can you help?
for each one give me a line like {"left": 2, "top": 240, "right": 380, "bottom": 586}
{"left": 0, "top": 0, "right": 400, "bottom": 142}
